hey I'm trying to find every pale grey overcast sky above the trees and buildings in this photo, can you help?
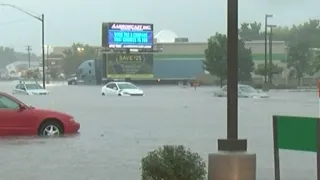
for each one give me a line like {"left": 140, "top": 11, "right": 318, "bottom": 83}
{"left": 0, "top": 0, "right": 320, "bottom": 54}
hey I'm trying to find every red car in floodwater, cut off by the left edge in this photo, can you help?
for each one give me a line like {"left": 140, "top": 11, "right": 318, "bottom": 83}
{"left": 0, "top": 92, "right": 80, "bottom": 136}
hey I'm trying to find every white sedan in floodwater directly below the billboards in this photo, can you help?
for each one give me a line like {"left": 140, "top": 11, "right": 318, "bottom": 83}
{"left": 101, "top": 82, "right": 144, "bottom": 96}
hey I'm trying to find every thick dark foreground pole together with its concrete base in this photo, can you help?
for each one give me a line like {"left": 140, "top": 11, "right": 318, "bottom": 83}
{"left": 208, "top": 0, "right": 256, "bottom": 180}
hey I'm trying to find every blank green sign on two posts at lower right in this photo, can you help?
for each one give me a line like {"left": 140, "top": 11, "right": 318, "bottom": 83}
{"left": 273, "top": 116, "right": 320, "bottom": 180}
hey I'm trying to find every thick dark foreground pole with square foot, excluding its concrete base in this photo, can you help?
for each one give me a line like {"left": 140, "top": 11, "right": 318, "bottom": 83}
{"left": 218, "top": 0, "right": 247, "bottom": 151}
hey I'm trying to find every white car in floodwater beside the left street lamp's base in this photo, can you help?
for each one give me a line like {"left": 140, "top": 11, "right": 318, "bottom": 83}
{"left": 12, "top": 82, "right": 49, "bottom": 95}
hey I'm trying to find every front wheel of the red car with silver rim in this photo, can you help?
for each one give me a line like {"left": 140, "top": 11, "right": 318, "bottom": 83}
{"left": 39, "top": 121, "right": 63, "bottom": 137}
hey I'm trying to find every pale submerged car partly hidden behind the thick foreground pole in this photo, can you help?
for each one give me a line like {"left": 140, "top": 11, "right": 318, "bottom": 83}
{"left": 214, "top": 84, "right": 269, "bottom": 98}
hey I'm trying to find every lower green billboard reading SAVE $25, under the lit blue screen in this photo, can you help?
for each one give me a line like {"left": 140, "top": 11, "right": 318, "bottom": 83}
{"left": 106, "top": 54, "right": 153, "bottom": 79}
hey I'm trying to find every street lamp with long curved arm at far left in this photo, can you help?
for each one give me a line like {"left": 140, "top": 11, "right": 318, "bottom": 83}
{"left": 0, "top": 4, "right": 46, "bottom": 89}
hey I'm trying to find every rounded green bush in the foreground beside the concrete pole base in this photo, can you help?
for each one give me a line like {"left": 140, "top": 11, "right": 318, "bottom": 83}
{"left": 141, "top": 145, "right": 207, "bottom": 180}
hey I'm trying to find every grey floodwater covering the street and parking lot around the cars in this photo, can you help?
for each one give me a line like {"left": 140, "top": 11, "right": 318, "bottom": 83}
{"left": 0, "top": 82, "right": 318, "bottom": 180}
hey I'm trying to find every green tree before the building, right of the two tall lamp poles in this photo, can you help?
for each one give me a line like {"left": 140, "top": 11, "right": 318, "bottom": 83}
{"left": 286, "top": 42, "right": 312, "bottom": 84}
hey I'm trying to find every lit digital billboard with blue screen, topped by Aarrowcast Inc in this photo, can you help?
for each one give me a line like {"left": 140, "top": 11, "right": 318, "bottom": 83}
{"left": 102, "top": 22, "right": 153, "bottom": 49}
